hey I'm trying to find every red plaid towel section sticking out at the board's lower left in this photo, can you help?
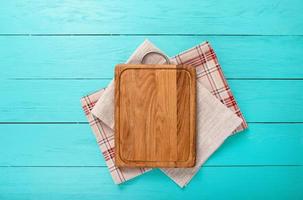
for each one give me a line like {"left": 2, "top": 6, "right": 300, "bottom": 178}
{"left": 81, "top": 89, "right": 150, "bottom": 184}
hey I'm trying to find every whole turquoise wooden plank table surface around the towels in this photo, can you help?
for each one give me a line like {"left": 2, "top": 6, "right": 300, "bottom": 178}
{"left": 0, "top": 0, "right": 303, "bottom": 200}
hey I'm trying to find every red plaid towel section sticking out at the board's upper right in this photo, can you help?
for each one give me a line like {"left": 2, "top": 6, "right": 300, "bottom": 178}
{"left": 171, "top": 42, "right": 248, "bottom": 133}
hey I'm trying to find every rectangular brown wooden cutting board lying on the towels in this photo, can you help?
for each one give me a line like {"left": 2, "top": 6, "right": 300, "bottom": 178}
{"left": 115, "top": 64, "right": 196, "bottom": 167}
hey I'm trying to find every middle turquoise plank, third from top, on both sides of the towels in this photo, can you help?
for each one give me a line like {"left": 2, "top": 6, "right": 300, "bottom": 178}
{"left": 0, "top": 80, "right": 303, "bottom": 122}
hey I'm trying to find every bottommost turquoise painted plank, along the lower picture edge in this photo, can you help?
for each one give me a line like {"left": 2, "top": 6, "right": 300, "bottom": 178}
{"left": 0, "top": 167, "right": 303, "bottom": 200}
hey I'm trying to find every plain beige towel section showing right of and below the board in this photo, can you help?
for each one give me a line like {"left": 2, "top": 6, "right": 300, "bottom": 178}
{"left": 161, "top": 81, "right": 242, "bottom": 187}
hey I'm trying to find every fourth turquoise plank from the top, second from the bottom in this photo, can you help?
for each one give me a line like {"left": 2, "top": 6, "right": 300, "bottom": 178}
{"left": 0, "top": 124, "right": 303, "bottom": 167}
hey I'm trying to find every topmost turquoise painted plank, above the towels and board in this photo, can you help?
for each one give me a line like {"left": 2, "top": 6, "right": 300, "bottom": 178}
{"left": 0, "top": 0, "right": 303, "bottom": 34}
